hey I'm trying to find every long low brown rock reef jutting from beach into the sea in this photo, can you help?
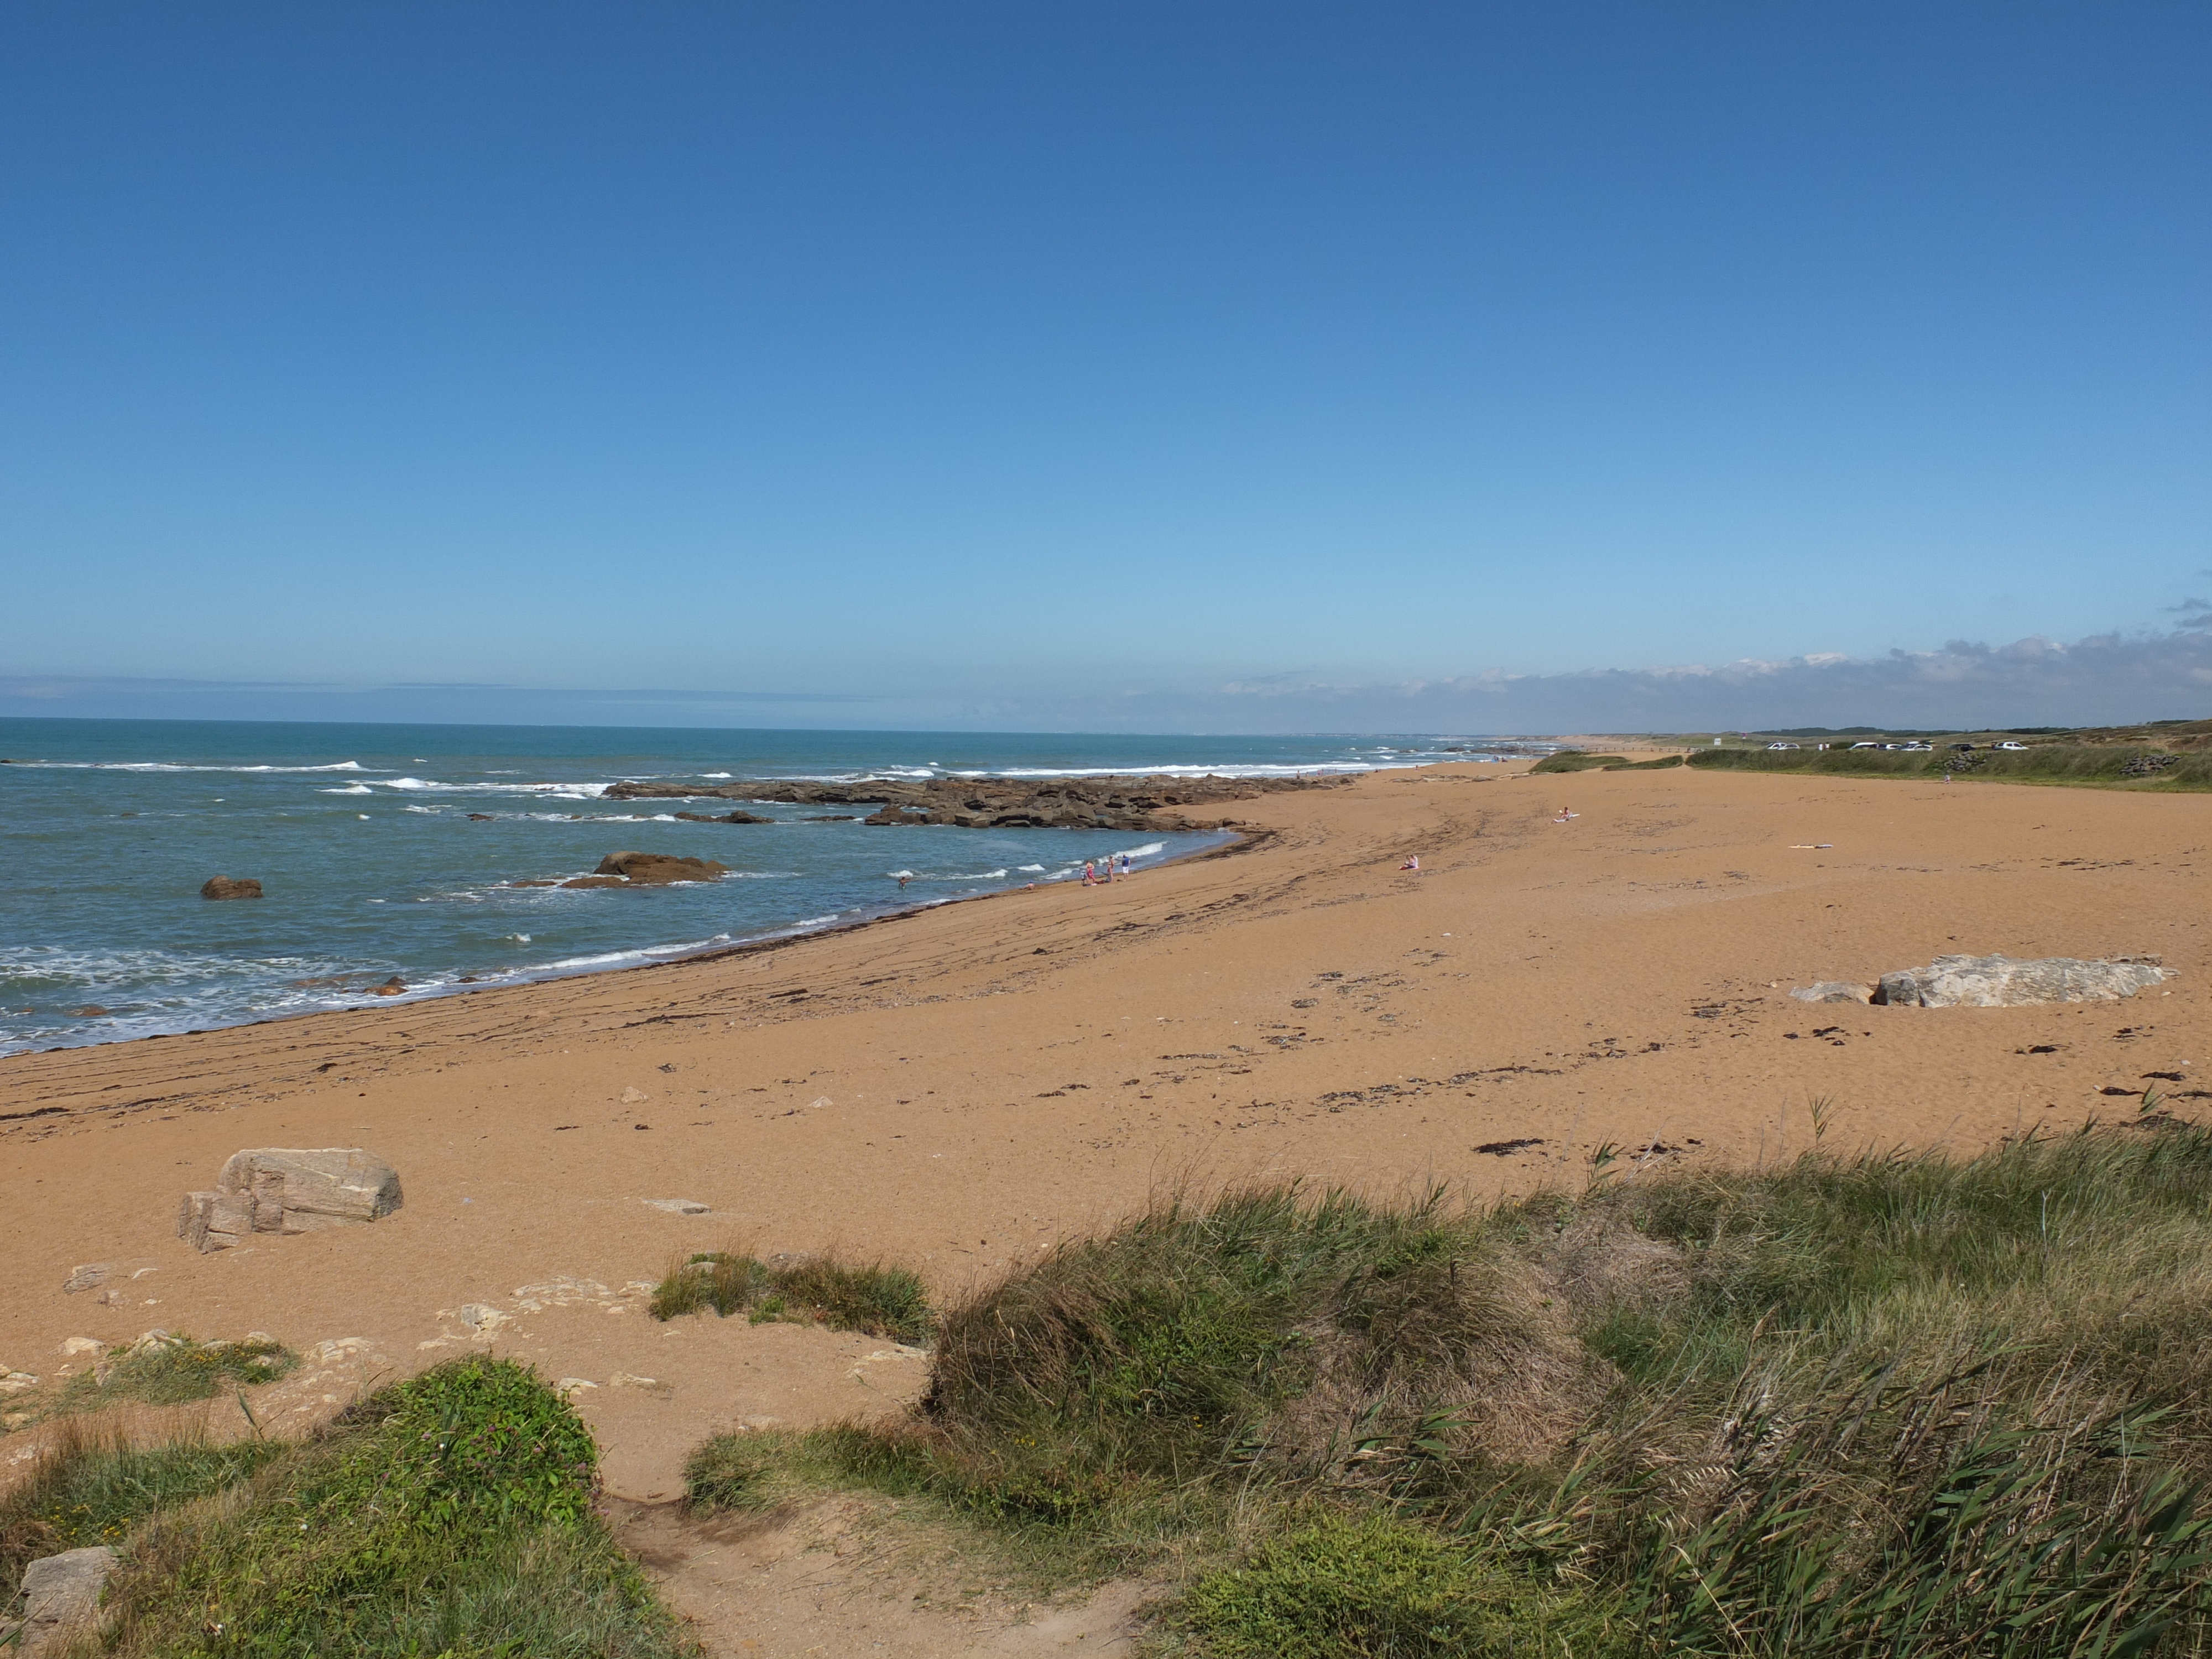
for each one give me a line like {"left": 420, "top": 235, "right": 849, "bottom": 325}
{"left": 599, "top": 776, "right": 1349, "bottom": 832}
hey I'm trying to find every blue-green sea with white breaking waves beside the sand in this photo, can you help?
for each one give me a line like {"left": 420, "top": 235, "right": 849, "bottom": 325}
{"left": 0, "top": 719, "right": 1522, "bottom": 1053}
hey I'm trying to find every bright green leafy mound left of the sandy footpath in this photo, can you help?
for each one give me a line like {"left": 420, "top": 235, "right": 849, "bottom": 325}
{"left": 76, "top": 1358, "right": 684, "bottom": 1659}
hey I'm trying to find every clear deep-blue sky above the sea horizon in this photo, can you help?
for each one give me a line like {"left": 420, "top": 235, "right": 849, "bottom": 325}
{"left": 0, "top": 0, "right": 2212, "bottom": 730}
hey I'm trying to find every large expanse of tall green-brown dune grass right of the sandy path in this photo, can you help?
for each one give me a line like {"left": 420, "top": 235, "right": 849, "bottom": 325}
{"left": 690, "top": 1119, "right": 2212, "bottom": 1659}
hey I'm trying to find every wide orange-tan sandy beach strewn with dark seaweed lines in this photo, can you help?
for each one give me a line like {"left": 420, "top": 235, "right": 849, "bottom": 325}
{"left": 0, "top": 765, "right": 2212, "bottom": 1500}
